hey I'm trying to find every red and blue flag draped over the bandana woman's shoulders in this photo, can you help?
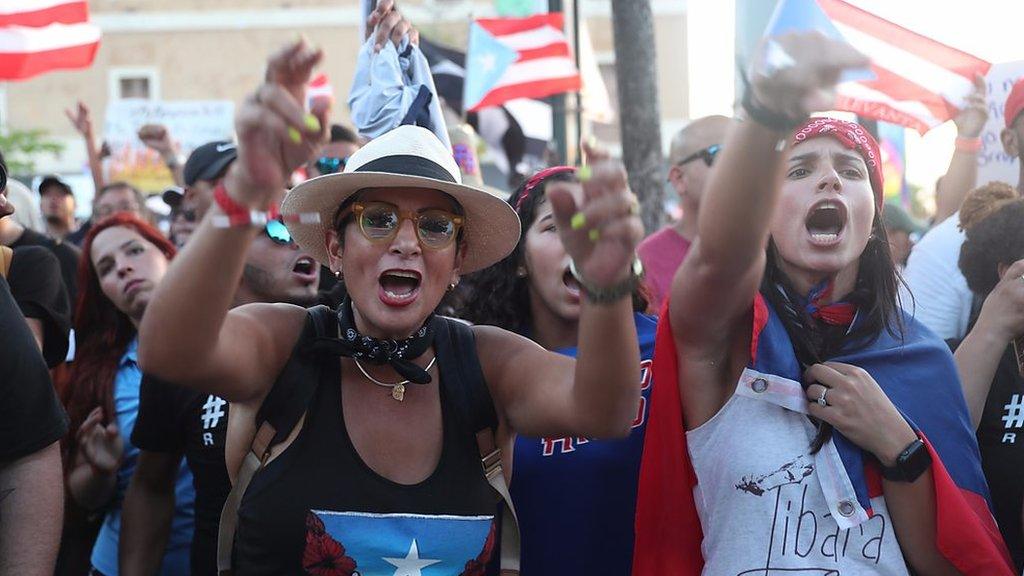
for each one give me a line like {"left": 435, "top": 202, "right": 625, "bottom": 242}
{"left": 633, "top": 295, "right": 1014, "bottom": 576}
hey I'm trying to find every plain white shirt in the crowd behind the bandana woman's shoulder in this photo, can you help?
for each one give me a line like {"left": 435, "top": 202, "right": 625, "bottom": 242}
{"left": 900, "top": 212, "right": 973, "bottom": 340}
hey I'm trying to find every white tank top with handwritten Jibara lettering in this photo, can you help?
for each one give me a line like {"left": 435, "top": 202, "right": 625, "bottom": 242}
{"left": 686, "top": 370, "right": 907, "bottom": 576}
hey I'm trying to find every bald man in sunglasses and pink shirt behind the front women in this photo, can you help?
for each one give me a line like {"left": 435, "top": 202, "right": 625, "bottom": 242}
{"left": 637, "top": 116, "right": 732, "bottom": 308}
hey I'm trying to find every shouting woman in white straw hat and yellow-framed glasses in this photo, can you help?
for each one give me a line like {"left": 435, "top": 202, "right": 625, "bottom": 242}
{"left": 139, "top": 41, "right": 642, "bottom": 575}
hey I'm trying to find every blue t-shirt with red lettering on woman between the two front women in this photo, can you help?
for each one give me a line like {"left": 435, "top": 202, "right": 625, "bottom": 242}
{"left": 509, "top": 314, "right": 657, "bottom": 576}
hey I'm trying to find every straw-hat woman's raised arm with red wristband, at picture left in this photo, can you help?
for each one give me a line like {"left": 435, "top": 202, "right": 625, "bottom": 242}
{"left": 138, "top": 40, "right": 329, "bottom": 401}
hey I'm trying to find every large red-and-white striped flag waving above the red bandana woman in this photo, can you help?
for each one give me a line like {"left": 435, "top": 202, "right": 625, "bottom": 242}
{"left": 768, "top": 0, "right": 991, "bottom": 133}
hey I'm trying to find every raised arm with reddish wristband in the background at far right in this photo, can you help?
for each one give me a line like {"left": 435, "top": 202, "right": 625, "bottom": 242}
{"left": 935, "top": 76, "right": 988, "bottom": 223}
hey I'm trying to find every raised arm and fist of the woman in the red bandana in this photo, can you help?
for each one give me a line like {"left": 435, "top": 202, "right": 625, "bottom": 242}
{"left": 669, "top": 34, "right": 867, "bottom": 350}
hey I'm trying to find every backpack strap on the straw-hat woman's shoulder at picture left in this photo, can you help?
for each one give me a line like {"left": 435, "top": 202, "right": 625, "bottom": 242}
{"left": 217, "top": 305, "right": 337, "bottom": 576}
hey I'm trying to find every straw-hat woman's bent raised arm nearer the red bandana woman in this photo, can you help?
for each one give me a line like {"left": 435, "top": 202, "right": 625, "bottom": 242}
{"left": 476, "top": 162, "right": 643, "bottom": 438}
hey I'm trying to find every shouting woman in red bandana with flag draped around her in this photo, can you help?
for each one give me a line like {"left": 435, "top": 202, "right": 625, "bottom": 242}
{"left": 634, "top": 35, "right": 1012, "bottom": 576}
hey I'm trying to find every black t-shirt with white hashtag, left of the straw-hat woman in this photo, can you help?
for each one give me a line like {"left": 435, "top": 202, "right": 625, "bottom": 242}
{"left": 131, "top": 375, "right": 231, "bottom": 576}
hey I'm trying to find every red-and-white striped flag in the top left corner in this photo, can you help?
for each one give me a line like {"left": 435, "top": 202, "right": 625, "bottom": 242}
{"left": 0, "top": 0, "right": 99, "bottom": 80}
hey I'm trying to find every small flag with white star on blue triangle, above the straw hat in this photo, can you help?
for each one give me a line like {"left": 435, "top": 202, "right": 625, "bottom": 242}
{"left": 463, "top": 12, "right": 581, "bottom": 112}
